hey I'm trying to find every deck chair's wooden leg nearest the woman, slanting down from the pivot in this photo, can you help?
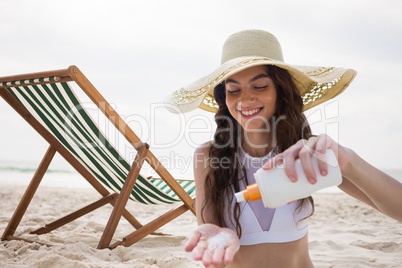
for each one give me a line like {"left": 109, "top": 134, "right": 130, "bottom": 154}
{"left": 98, "top": 144, "right": 149, "bottom": 249}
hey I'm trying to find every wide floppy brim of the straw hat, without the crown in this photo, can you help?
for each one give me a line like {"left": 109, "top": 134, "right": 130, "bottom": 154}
{"left": 165, "top": 57, "right": 356, "bottom": 113}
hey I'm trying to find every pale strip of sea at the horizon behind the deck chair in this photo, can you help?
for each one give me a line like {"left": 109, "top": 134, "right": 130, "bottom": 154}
{"left": 0, "top": 160, "right": 402, "bottom": 192}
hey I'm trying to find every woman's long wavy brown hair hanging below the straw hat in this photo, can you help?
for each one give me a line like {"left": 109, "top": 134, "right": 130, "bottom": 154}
{"left": 201, "top": 65, "right": 314, "bottom": 236}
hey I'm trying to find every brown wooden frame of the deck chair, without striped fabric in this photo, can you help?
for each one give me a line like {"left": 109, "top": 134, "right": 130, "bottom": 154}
{"left": 0, "top": 66, "right": 195, "bottom": 249}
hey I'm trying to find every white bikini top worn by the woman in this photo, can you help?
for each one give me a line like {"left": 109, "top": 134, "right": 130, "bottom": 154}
{"left": 228, "top": 148, "right": 311, "bottom": 245}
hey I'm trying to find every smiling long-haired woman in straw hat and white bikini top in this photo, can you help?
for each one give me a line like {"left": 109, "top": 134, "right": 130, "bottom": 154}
{"left": 164, "top": 30, "right": 402, "bottom": 268}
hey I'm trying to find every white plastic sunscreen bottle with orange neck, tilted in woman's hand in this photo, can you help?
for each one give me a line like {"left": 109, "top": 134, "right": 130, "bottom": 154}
{"left": 235, "top": 150, "right": 342, "bottom": 208}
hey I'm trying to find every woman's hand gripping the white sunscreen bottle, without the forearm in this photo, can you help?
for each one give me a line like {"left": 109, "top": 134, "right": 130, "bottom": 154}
{"left": 263, "top": 134, "right": 349, "bottom": 184}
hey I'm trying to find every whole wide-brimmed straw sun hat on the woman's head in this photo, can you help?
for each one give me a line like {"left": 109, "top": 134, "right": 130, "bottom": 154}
{"left": 165, "top": 30, "right": 356, "bottom": 113}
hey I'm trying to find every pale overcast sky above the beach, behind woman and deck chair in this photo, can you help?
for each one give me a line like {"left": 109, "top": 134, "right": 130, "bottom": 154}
{"left": 0, "top": 0, "right": 402, "bottom": 177}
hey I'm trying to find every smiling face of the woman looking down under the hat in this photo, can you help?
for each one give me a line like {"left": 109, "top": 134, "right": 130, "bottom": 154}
{"left": 225, "top": 66, "right": 277, "bottom": 132}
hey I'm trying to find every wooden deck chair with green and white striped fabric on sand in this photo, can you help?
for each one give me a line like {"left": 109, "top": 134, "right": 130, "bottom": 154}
{"left": 0, "top": 66, "right": 195, "bottom": 249}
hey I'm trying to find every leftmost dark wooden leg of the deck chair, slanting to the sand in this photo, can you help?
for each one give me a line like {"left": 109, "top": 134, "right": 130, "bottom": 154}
{"left": 1, "top": 145, "right": 56, "bottom": 240}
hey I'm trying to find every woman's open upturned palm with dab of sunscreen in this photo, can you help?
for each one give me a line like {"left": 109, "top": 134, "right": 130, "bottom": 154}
{"left": 185, "top": 224, "right": 240, "bottom": 267}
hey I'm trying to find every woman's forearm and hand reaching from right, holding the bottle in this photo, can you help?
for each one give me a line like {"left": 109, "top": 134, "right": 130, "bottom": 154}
{"left": 264, "top": 135, "right": 402, "bottom": 221}
